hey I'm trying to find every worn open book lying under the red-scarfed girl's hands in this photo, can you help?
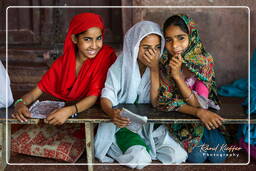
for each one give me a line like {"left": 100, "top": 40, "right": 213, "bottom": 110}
{"left": 29, "top": 100, "right": 65, "bottom": 119}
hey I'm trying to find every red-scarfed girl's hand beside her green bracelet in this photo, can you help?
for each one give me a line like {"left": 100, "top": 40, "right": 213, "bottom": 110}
{"left": 12, "top": 103, "right": 32, "bottom": 122}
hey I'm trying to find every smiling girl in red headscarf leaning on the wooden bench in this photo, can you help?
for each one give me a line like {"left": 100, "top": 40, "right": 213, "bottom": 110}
{"left": 12, "top": 13, "right": 116, "bottom": 162}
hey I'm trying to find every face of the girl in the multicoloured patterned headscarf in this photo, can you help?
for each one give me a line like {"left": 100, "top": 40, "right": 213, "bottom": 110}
{"left": 165, "top": 25, "right": 189, "bottom": 56}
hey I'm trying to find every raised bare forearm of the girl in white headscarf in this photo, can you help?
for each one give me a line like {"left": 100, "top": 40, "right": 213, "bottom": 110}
{"left": 150, "top": 67, "right": 159, "bottom": 107}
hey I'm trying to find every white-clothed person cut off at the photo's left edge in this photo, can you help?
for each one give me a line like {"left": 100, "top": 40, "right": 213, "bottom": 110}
{"left": 0, "top": 61, "right": 13, "bottom": 108}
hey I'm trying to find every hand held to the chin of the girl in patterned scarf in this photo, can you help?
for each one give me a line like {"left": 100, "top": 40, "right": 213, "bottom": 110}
{"left": 169, "top": 54, "right": 182, "bottom": 79}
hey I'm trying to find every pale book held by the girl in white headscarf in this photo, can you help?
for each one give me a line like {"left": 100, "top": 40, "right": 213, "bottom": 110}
{"left": 120, "top": 108, "right": 148, "bottom": 133}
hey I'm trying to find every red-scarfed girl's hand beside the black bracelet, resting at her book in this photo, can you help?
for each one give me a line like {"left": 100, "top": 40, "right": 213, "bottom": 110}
{"left": 44, "top": 106, "right": 74, "bottom": 125}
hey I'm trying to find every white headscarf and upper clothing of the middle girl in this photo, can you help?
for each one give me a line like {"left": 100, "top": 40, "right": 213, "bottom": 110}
{"left": 101, "top": 21, "right": 165, "bottom": 106}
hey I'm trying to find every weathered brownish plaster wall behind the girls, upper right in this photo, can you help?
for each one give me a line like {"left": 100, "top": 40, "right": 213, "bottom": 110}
{"left": 123, "top": 0, "right": 256, "bottom": 86}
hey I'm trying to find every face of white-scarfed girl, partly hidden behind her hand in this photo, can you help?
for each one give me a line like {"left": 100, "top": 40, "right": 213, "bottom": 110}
{"left": 138, "top": 34, "right": 161, "bottom": 65}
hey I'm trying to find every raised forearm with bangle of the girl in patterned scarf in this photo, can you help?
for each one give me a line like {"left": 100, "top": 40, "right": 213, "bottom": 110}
{"left": 174, "top": 77, "right": 200, "bottom": 107}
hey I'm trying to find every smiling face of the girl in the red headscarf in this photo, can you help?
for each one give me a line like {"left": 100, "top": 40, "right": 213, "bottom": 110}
{"left": 72, "top": 27, "right": 103, "bottom": 60}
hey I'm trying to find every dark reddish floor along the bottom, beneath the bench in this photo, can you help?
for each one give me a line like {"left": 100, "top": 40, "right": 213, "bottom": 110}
{"left": 5, "top": 151, "right": 256, "bottom": 171}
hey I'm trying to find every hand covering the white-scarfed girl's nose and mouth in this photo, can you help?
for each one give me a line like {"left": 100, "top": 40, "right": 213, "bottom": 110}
{"left": 142, "top": 49, "right": 160, "bottom": 70}
